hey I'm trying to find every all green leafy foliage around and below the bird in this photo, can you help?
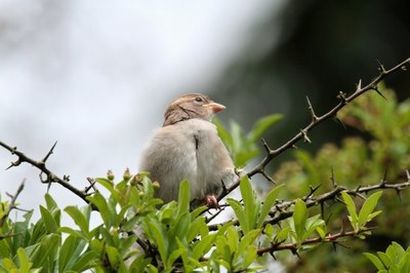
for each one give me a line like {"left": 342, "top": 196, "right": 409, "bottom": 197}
{"left": 0, "top": 84, "right": 410, "bottom": 273}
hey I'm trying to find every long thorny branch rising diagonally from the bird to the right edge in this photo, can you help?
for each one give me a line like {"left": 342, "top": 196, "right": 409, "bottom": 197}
{"left": 221, "top": 58, "right": 410, "bottom": 201}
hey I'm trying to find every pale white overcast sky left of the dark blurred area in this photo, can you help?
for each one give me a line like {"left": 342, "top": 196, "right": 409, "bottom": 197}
{"left": 0, "top": 0, "right": 279, "bottom": 223}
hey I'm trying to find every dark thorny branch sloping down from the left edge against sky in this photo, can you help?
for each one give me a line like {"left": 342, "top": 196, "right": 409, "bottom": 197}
{"left": 0, "top": 141, "right": 89, "bottom": 203}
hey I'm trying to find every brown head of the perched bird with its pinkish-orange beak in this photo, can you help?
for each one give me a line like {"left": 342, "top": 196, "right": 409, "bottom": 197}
{"left": 163, "top": 93, "right": 225, "bottom": 126}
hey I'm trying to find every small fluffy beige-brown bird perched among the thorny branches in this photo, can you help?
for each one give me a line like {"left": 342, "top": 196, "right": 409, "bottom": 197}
{"left": 140, "top": 93, "right": 237, "bottom": 207}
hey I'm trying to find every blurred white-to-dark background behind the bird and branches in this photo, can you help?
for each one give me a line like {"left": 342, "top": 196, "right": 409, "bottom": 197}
{"left": 0, "top": 0, "right": 410, "bottom": 272}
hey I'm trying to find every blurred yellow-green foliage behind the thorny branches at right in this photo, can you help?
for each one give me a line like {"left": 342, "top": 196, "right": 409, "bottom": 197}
{"left": 274, "top": 85, "right": 410, "bottom": 272}
